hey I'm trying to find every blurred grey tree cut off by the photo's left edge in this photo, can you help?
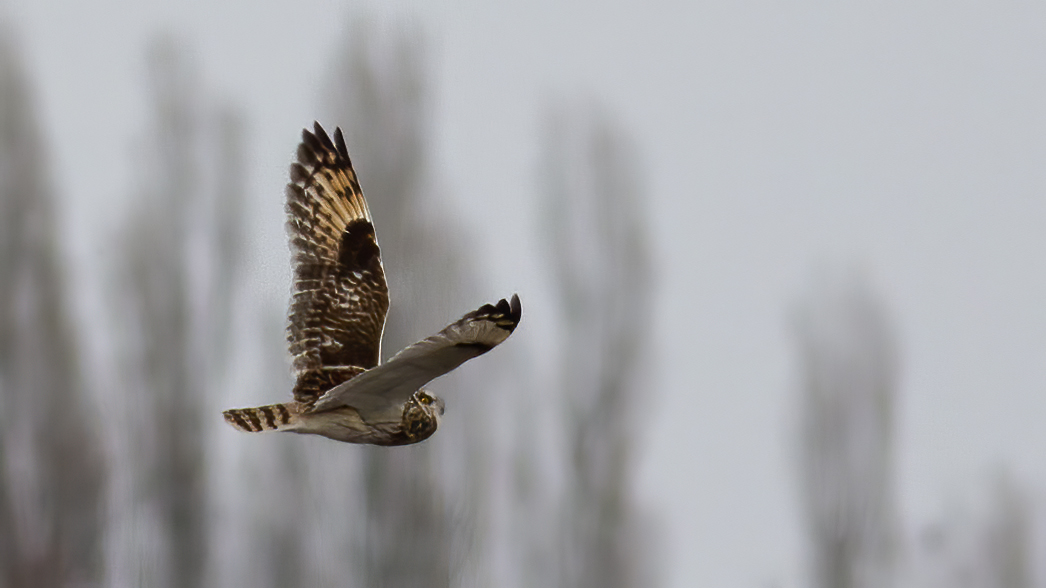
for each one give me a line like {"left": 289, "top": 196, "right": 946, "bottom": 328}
{"left": 0, "top": 27, "right": 106, "bottom": 588}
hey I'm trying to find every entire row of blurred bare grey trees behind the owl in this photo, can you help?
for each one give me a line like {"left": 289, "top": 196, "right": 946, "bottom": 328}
{"left": 0, "top": 13, "right": 1034, "bottom": 588}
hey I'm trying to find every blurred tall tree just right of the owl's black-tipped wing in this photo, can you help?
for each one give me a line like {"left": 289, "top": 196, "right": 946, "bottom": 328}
{"left": 542, "top": 105, "right": 653, "bottom": 588}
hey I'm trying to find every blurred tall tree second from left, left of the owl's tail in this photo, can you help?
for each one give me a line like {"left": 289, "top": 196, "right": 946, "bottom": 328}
{"left": 110, "top": 39, "right": 244, "bottom": 588}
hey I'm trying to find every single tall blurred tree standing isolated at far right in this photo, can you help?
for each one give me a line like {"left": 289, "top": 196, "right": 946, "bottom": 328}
{"left": 796, "top": 275, "right": 897, "bottom": 588}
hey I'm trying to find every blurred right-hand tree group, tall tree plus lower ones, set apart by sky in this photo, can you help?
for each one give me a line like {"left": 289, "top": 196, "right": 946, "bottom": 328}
{"left": 792, "top": 270, "right": 1042, "bottom": 588}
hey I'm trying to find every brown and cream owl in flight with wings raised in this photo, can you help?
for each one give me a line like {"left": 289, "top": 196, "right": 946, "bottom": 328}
{"left": 223, "top": 122, "right": 521, "bottom": 446}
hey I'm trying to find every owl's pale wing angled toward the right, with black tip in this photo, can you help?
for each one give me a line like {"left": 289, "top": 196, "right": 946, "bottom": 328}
{"left": 313, "top": 295, "right": 522, "bottom": 422}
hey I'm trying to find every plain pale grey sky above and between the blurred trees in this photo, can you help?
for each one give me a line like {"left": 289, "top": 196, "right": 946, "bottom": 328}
{"left": 0, "top": 0, "right": 1046, "bottom": 588}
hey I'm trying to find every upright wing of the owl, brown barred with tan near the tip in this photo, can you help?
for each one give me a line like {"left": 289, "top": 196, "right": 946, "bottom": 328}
{"left": 287, "top": 122, "right": 389, "bottom": 402}
